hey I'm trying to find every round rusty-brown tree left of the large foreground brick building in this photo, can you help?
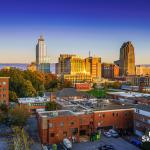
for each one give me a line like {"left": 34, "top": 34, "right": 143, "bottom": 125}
{"left": 9, "top": 105, "right": 30, "bottom": 127}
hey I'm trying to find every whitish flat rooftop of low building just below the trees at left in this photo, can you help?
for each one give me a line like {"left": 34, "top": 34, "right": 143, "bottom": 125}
{"left": 18, "top": 97, "right": 49, "bottom": 104}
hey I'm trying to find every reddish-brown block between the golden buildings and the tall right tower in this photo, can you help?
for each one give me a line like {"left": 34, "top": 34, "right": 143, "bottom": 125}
{"left": 102, "top": 63, "right": 119, "bottom": 79}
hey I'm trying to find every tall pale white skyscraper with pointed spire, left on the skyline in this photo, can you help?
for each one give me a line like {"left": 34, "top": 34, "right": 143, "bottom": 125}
{"left": 36, "top": 36, "right": 46, "bottom": 66}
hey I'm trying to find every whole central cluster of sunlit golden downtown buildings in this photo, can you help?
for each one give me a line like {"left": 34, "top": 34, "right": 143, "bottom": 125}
{"left": 56, "top": 54, "right": 101, "bottom": 84}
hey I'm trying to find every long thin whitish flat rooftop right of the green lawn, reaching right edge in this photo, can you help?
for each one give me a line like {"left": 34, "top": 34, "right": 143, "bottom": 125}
{"left": 107, "top": 92, "right": 150, "bottom": 98}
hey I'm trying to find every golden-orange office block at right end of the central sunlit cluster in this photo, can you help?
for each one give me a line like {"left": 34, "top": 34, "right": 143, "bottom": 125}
{"left": 85, "top": 57, "right": 101, "bottom": 81}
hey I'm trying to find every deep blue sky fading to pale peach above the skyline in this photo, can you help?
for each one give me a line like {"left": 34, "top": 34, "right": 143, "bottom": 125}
{"left": 0, "top": 0, "right": 150, "bottom": 64}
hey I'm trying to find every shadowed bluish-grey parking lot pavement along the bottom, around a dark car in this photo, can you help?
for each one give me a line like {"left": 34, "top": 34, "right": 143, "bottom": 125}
{"left": 73, "top": 137, "right": 140, "bottom": 150}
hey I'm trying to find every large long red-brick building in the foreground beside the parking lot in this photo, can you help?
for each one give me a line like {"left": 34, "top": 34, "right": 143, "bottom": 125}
{"left": 37, "top": 108, "right": 134, "bottom": 144}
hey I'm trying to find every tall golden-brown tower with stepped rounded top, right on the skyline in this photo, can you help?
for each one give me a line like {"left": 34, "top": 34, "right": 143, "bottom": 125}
{"left": 119, "top": 41, "right": 135, "bottom": 76}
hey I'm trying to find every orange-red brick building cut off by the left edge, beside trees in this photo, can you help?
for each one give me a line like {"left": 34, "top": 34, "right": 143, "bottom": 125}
{"left": 0, "top": 77, "right": 9, "bottom": 105}
